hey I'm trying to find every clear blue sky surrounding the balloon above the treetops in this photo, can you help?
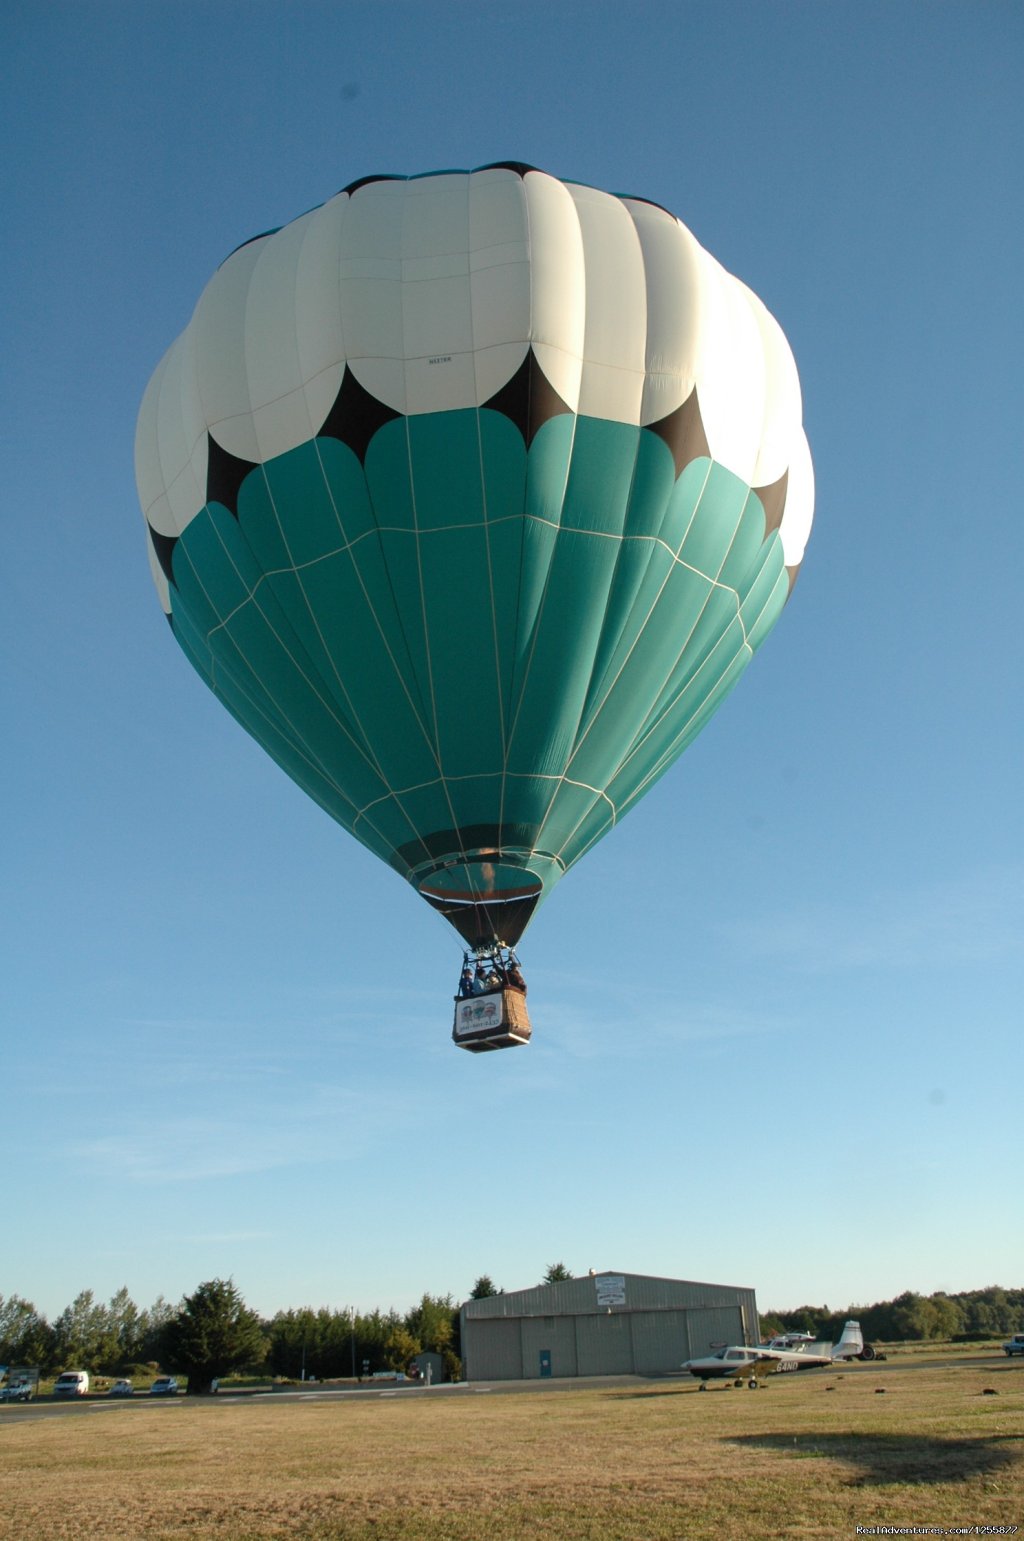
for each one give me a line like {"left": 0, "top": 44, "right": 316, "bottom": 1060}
{"left": 0, "top": 0, "right": 1024, "bottom": 1316}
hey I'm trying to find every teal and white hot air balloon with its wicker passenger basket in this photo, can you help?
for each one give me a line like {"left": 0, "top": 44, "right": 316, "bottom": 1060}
{"left": 136, "top": 163, "right": 813, "bottom": 1048}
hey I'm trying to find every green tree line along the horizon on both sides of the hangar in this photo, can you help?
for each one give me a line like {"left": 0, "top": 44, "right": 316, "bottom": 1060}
{"left": 0, "top": 1262, "right": 1024, "bottom": 1393}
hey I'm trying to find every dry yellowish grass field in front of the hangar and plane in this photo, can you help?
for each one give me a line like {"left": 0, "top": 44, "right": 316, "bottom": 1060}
{"left": 0, "top": 1355, "right": 1024, "bottom": 1541}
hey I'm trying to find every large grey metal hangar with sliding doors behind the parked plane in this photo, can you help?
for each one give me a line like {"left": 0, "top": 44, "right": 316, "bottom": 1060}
{"left": 460, "top": 1273, "right": 758, "bottom": 1381}
